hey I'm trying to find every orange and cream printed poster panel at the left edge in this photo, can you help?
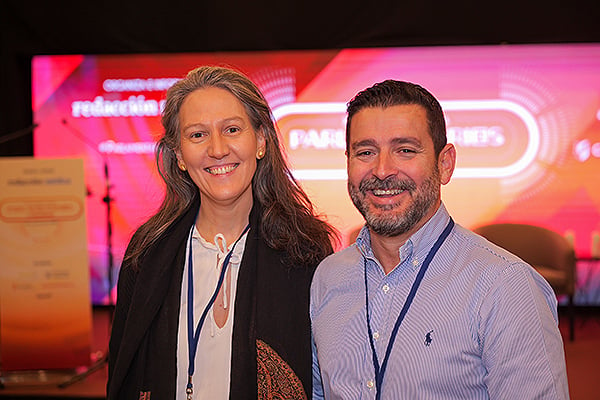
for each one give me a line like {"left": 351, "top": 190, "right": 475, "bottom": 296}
{"left": 0, "top": 157, "right": 92, "bottom": 371}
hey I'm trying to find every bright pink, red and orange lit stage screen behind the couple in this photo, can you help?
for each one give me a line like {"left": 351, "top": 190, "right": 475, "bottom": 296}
{"left": 33, "top": 44, "right": 600, "bottom": 303}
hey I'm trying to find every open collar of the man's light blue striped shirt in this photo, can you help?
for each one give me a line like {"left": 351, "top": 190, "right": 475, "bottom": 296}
{"left": 356, "top": 203, "right": 450, "bottom": 268}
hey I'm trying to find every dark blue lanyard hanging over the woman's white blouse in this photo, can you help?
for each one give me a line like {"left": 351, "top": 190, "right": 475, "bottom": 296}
{"left": 185, "top": 224, "right": 250, "bottom": 399}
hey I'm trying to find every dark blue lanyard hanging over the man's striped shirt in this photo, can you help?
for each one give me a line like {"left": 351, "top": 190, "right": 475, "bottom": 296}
{"left": 364, "top": 218, "right": 454, "bottom": 400}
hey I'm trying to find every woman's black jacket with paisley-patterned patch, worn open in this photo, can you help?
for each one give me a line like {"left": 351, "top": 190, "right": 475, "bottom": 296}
{"left": 107, "top": 202, "right": 316, "bottom": 400}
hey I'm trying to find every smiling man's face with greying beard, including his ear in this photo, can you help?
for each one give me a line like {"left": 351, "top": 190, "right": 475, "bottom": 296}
{"left": 347, "top": 104, "right": 454, "bottom": 237}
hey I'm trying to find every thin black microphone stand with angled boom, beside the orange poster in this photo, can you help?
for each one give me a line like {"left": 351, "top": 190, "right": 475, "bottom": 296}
{"left": 58, "top": 119, "right": 115, "bottom": 388}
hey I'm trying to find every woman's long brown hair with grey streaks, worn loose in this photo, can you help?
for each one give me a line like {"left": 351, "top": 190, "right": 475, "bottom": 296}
{"left": 124, "top": 66, "right": 337, "bottom": 267}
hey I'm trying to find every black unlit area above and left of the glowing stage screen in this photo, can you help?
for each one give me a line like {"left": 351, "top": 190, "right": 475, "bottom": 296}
{"left": 0, "top": 0, "right": 600, "bottom": 156}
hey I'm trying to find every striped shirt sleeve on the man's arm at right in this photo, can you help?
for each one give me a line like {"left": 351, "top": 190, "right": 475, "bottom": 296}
{"left": 479, "top": 263, "right": 569, "bottom": 400}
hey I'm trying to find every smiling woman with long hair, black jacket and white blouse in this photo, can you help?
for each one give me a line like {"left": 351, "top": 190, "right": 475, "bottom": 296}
{"left": 107, "top": 67, "right": 335, "bottom": 400}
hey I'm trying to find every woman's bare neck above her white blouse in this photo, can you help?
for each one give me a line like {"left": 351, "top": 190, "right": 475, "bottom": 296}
{"left": 196, "top": 200, "right": 252, "bottom": 244}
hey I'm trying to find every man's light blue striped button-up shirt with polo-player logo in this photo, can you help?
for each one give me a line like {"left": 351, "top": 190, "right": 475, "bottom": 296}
{"left": 310, "top": 204, "right": 569, "bottom": 400}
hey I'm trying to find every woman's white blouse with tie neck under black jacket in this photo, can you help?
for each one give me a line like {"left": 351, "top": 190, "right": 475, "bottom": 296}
{"left": 176, "top": 225, "right": 248, "bottom": 400}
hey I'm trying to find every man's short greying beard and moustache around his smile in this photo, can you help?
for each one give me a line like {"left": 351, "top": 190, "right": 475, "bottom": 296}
{"left": 348, "top": 168, "right": 440, "bottom": 237}
